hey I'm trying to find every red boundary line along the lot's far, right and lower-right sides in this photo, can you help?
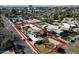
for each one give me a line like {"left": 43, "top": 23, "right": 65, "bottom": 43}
{"left": 15, "top": 22, "right": 67, "bottom": 53}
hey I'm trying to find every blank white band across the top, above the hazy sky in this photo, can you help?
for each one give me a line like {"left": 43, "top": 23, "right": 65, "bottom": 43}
{"left": 0, "top": 0, "right": 79, "bottom": 5}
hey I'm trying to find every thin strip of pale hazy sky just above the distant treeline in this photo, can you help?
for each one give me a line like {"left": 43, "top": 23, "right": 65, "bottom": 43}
{"left": 0, "top": 5, "right": 79, "bottom": 7}
